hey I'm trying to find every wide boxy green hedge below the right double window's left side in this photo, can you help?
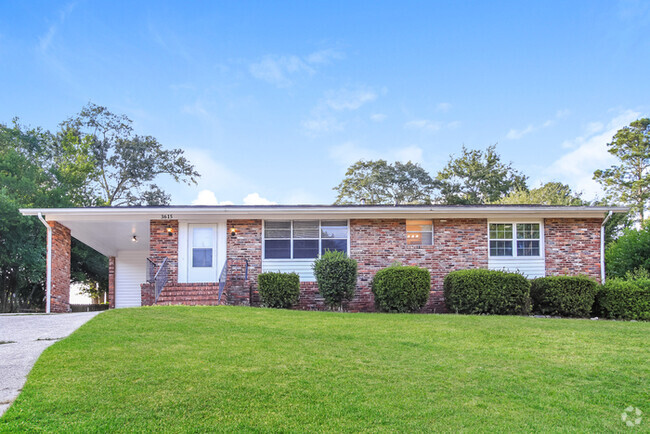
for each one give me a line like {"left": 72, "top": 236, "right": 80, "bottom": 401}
{"left": 444, "top": 269, "right": 530, "bottom": 315}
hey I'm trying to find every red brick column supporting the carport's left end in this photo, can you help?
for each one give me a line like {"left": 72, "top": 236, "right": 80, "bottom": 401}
{"left": 48, "top": 222, "right": 71, "bottom": 313}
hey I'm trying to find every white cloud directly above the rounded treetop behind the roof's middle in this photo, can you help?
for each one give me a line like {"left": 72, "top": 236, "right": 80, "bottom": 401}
{"left": 329, "top": 141, "right": 424, "bottom": 168}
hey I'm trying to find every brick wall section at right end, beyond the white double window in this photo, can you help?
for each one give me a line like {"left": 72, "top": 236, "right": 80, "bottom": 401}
{"left": 544, "top": 219, "right": 602, "bottom": 281}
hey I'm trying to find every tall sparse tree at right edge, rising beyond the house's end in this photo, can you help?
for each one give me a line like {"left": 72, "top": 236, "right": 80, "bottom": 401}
{"left": 594, "top": 118, "right": 650, "bottom": 222}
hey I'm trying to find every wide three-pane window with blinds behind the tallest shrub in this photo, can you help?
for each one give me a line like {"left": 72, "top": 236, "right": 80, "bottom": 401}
{"left": 263, "top": 220, "right": 349, "bottom": 259}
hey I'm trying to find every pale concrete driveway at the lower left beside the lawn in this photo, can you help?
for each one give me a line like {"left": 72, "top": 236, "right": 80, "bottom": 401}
{"left": 0, "top": 312, "right": 100, "bottom": 416}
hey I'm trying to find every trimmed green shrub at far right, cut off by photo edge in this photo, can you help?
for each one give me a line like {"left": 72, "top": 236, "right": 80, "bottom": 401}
{"left": 594, "top": 279, "right": 650, "bottom": 321}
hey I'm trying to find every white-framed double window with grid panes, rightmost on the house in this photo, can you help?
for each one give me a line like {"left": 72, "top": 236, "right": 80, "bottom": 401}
{"left": 488, "top": 222, "right": 542, "bottom": 258}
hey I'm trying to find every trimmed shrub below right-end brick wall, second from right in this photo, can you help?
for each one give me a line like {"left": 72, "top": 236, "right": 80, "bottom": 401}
{"left": 530, "top": 276, "right": 598, "bottom": 317}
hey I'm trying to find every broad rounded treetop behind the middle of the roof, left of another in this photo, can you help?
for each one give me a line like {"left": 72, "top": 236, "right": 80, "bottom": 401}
{"left": 334, "top": 160, "right": 436, "bottom": 205}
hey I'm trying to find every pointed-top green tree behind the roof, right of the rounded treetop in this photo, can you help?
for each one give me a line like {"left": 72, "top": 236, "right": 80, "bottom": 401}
{"left": 436, "top": 145, "right": 527, "bottom": 205}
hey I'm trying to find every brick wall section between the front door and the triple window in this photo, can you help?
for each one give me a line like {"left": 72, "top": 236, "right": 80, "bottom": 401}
{"left": 226, "top": 220, "right": 262, "bottom": 305}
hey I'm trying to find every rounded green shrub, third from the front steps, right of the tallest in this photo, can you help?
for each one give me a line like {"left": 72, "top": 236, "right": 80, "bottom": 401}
{"left": 372, "top": 265, "right": 431, "bottom": 312}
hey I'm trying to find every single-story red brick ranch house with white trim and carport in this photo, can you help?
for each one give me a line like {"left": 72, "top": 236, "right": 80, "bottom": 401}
{"left": 21, "top": 205, "right": 627, "bottom": 312}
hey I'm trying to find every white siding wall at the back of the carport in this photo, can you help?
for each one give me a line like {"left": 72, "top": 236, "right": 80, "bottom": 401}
{"left": 115, "top": 250, "right": 148, "bottom": 307}
